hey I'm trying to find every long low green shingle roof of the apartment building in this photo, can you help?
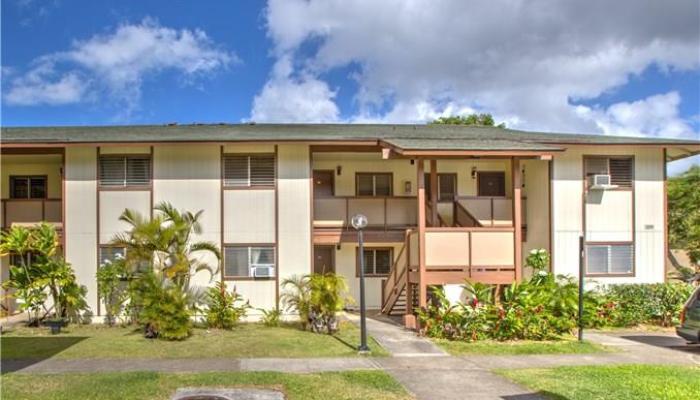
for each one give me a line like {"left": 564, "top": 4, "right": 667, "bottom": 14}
{"left": 0, "top": 124, "right": 700, "bottom": 151}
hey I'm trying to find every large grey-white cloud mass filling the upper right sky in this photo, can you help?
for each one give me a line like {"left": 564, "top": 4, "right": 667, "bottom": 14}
{"left": 264, "top": 0, "right": 700, "bottom": 132}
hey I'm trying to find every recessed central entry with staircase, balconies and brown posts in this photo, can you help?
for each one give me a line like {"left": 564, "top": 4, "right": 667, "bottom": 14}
{"left": 312, "top": 142, "right": 551, "bottom": 322}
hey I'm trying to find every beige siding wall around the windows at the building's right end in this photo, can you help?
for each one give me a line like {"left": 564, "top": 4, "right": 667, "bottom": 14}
{"left": 552, "top": 146, "right": 664, "bottom": 283}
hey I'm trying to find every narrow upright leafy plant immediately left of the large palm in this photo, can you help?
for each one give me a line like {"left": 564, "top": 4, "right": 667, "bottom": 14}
{"left": 96, "top": 255, "right": 129, "bottom": 326}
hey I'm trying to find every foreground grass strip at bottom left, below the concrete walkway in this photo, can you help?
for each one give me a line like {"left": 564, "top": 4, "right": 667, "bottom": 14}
{"left": 1, "top": 371, "right": 411, "bottom": 400}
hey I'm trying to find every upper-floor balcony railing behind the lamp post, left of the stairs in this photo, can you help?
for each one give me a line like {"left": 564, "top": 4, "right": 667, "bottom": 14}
{"left": 314, "top": 196, "right": 418, "bottom": 230}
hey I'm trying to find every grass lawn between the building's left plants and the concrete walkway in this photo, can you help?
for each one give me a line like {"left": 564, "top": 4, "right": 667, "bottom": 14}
{"left": 0, "top": 322, "right": 387, "bottom": 360}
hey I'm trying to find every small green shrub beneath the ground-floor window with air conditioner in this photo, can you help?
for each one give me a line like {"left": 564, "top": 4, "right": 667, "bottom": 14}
{"left": 206, "top": 282, "right": 250, "bottom": 329}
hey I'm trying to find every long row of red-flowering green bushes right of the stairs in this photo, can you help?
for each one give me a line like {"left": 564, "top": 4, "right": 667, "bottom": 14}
{"left": 418, "top": 249, "right": 692, "bottom": 341}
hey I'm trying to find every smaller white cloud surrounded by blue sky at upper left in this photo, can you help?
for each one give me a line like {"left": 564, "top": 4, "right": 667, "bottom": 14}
{"left": 5, "top": 19, "right": 237, "bottom": 108}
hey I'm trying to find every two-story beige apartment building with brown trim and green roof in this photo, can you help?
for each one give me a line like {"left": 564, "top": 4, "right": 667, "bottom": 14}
{"left": 0, "top": 124, "right": 700, "bottom": 323}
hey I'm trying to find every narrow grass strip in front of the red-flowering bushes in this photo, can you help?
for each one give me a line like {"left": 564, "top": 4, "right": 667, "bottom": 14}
{"left": 433, "top": 339, "right": 611, "bottom": 356}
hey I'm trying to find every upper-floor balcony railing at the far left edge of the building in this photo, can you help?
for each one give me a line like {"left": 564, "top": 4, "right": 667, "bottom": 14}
{"left": 1, "top": 199, "right": 63, "bottom": 228}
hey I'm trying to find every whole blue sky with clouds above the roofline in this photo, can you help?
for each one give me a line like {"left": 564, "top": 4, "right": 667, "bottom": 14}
{"left": 1, "top": 0, "right": 700, "bottom": 172}
